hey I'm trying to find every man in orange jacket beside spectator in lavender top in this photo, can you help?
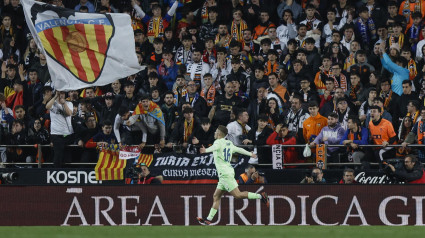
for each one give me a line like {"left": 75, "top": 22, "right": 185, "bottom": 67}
{"left": 303, "top": 101, "right": 328, "bottom": 143}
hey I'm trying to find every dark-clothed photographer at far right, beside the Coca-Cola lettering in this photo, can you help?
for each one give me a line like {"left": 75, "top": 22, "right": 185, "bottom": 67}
{"left": 384, "top": 155, "right": 425, "bottom": 183}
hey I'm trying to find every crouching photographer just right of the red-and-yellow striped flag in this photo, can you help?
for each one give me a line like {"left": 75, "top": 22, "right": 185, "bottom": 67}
{"left": 125, "top": 163, "right": 163, "bottom": 184}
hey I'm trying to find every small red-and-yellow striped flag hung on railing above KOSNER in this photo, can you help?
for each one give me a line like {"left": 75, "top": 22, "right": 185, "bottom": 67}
{"left": 95, "top": 145, "right": 127, "bottom": 180}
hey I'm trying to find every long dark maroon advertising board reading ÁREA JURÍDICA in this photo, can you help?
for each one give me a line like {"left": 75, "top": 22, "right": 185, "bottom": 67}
{"left": 0, "top": 184, "right": 425, "bottom": 226}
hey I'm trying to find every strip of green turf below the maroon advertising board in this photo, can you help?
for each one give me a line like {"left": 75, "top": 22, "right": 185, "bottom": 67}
{"left": 0, "top": 226, "right": 425, "bottom": 238}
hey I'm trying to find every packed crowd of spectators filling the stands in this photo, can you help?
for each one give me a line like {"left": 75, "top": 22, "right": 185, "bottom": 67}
{"left": 0, "top": 0, "right": 425, "bottom": 171}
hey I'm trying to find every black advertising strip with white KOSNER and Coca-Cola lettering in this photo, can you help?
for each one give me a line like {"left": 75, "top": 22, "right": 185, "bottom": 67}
{"left": 0, "top": 168, "right": 390, "bottom": 187}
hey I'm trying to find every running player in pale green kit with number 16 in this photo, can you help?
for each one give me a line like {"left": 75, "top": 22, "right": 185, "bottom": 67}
{"left": 196, "top": 125, "right": 269, "bottom": 225}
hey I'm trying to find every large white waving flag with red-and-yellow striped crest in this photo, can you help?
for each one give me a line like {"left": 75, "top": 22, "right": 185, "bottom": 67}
{"left": 21, "top": 0, "right": 141, "bottom": 91}
